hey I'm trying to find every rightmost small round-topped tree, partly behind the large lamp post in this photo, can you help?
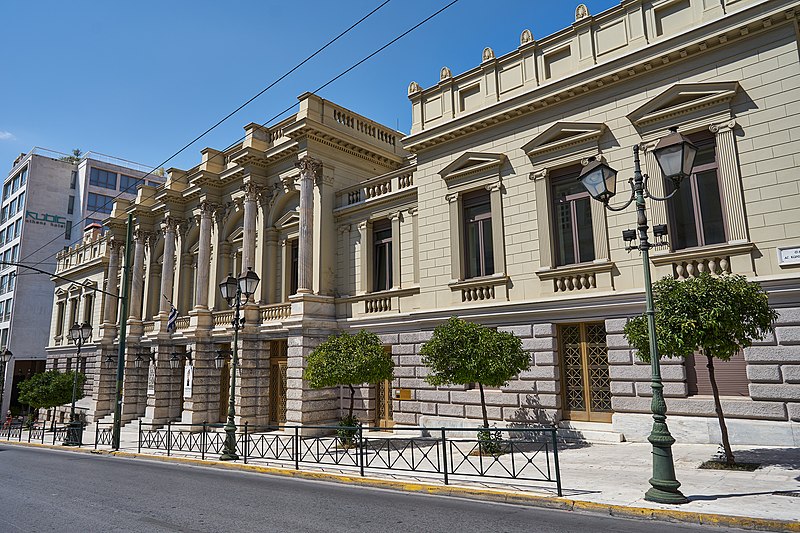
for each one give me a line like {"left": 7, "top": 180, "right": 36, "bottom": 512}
{"left": 625, "top": 272, "right": 778, "bottom": 465}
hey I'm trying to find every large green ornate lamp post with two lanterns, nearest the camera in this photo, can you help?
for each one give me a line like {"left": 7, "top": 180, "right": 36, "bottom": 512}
{"left": 578, "top": 128, "right": 697, "bottom": 504}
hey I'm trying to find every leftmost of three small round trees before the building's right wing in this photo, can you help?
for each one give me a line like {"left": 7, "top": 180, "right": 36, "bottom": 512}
{"left": 303, "top": 330, "right": 394, "bottom": 438}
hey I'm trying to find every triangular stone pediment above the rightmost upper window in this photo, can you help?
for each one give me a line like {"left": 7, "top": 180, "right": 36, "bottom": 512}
{"left": 628, "top": 81, "right": 739, "bottom": 127}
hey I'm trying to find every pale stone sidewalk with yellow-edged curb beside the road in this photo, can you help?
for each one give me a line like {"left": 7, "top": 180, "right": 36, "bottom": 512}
{"left": 4, "top": 431, "right": 800, "bottom": 531}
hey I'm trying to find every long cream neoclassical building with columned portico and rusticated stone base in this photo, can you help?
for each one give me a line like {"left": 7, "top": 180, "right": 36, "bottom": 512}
{"left": 49, "top": 0, "right": 800, "bottom": 445}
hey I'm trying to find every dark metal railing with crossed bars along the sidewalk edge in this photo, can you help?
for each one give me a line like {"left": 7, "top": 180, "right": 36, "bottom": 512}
{"left": 100, "top": 421, "right": 561, "bottom": 496}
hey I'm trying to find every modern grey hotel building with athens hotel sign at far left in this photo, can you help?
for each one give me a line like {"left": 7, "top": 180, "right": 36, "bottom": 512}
{"left": 0, "top": 148, "right": 164, "bottom": 413}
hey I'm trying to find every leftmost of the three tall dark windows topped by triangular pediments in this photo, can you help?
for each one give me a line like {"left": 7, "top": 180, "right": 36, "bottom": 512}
{"left": 463, "top": 191, "right": 494, "bottom": 278}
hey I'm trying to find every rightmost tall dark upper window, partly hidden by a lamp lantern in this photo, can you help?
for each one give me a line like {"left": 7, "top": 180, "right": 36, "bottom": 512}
{"left": 665, "top": 132, "right": 727, "bottom": 250}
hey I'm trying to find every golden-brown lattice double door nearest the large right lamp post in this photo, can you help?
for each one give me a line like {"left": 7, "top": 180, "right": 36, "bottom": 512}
{"left": 558, "top": 322, "right": 612, "bottom": 422}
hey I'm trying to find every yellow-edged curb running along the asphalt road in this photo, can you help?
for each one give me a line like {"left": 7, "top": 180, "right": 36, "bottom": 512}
{"left": 0, "top": 441, "right": 800, "bottom": 533}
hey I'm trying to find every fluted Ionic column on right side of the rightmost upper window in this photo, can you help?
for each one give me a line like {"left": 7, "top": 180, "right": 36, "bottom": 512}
{"left": 708, "top": 120, "right": 749, "bottom": 244}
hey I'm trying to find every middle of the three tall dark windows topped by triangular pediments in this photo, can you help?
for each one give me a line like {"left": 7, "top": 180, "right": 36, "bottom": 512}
{"left": 551, "top": 166, "right": 595, "bottom": 266}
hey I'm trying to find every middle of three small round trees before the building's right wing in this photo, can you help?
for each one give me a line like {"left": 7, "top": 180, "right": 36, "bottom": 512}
{"left": 420, "top": 317, "right": 531, "bottom": 429}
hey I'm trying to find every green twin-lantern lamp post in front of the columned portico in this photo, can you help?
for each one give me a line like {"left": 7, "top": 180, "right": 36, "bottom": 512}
{"left": 215, "top": 267, "right": 260, "bottom": 461}
